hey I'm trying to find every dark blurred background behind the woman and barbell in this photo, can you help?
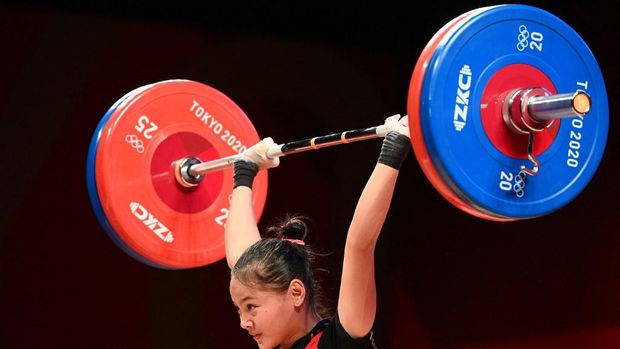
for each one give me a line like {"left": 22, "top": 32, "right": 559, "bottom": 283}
{"left": 0, "top": 1, "right": 620, "bottom": 349}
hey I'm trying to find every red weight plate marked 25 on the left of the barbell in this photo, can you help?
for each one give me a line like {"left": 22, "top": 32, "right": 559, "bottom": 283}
{"left": 95, "top": 80, "right": 267, "bottom": 268}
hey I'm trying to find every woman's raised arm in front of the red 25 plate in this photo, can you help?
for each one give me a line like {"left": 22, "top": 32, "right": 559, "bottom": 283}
{"left": 224, "top": 138, "right": 280, "bottom": 269}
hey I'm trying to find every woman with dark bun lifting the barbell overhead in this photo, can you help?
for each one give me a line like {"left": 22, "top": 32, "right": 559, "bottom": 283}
{"left": 225, "top": 115, "right": 411, "bottom": 349}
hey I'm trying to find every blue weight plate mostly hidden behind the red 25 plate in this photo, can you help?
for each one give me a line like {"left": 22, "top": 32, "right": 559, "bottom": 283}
{"left": 86, "top": 84, "right": 170, "bottom": 269}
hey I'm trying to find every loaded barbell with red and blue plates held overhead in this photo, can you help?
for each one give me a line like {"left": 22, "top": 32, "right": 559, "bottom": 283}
{"left": 86, "top": 5, "right": 609, "bottom": 269}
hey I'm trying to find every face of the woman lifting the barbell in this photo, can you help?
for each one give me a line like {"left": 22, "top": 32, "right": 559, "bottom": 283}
{"left": 230, "top": 277, "right": 299, "bottom": 349}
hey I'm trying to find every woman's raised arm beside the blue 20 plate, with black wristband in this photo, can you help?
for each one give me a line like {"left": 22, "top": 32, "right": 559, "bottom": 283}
{"left": 338, "top": 117, "right": 411, "bottom": 338}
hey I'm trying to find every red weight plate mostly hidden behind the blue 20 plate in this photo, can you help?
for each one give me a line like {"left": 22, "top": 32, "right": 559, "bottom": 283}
{"left": 407, "top": 7, "right": 514, "bottom": 222}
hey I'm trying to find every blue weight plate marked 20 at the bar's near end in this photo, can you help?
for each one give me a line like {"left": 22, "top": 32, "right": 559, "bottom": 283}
{"left": 420, "top": 5, "right": 609, "bottom": 219}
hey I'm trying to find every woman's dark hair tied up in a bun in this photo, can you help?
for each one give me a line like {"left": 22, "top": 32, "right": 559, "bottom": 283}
{"left": 231, "top": 216, "right": 331, "bottom": 318}
